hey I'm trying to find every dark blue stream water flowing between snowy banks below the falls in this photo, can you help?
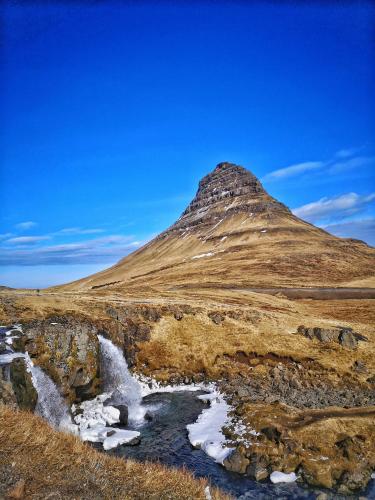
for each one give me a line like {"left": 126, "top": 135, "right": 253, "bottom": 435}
{"left": 94, "top": 391, "right": 334, "bottom": 499}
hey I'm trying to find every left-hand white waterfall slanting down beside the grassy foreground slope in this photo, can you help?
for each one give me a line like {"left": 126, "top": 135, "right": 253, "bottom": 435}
{"left": 25, "top": 353, "right": 75, "bottom": 432}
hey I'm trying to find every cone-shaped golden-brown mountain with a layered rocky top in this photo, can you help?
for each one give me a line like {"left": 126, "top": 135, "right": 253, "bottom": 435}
{"left": 63, "top": 162, "right": 375, "bottom": 290}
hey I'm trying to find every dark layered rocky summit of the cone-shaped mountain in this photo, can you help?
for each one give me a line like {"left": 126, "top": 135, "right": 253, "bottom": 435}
{"left": 163, "top": 162, "right": 290, "bottom": 236}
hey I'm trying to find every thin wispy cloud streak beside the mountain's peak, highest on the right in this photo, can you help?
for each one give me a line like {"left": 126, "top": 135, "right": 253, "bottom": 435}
{"left": 262, "top": 148, "right": 375, "bottom": 182}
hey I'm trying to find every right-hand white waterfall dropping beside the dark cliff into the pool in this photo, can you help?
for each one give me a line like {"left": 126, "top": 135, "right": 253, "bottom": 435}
{"left": 98, "top": 335, "right": 146, "bottom": 423}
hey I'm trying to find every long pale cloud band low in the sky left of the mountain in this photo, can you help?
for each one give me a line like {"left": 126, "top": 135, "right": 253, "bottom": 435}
{"left": 0, "top": 235, "right": 142, "bottom": 266}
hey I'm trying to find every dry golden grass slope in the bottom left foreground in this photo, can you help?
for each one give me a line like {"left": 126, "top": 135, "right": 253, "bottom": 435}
{"left": 0, "top": 405, "right": 230, "bottom": 500}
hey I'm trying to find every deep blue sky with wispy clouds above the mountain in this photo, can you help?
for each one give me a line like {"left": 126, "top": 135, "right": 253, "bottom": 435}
{"left": 0, "top": 1, "right": 375, "bottom": 287}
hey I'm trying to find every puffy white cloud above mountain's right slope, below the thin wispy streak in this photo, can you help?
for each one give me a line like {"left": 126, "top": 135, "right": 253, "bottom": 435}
{"left": 292, "top": 193, "right": 375, "bottom": 222}
